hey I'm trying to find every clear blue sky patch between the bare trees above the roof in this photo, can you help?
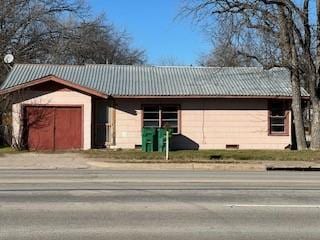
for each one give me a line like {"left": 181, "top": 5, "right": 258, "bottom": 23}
{"left": 88, "top": 0, "right": 210, "bottom": 65}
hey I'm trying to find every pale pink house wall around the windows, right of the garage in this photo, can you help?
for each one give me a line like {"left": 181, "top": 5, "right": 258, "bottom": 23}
{"left": 115, "top": 99, "right": 291, "bottom": 149}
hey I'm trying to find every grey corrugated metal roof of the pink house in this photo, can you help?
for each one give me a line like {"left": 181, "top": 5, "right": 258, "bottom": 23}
{"left": 0, "top": 64, "right": 308, "bottom": 97}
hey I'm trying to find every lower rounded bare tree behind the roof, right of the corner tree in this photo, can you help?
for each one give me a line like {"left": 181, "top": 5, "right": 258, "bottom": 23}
{"left": 48, "top": 16, "right": 145, "bottom": 65}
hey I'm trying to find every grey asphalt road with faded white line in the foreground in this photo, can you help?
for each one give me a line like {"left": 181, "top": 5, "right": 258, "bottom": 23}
{"left": 0, "top": 170, "right": 320, "bottom": 240}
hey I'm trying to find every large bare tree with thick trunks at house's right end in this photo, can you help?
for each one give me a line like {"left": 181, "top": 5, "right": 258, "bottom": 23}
{"left": 183, "top": 0, "right": 320, "bottom": 149}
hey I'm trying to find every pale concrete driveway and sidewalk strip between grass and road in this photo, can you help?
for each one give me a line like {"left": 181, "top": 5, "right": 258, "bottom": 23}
{"left": 0, "top": 152, "right": 320, "bottom": 171}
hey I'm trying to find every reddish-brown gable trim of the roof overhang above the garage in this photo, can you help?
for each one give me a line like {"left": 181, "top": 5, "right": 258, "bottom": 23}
{"left": 0, "top": 75, "right": 109, "bottom": 99}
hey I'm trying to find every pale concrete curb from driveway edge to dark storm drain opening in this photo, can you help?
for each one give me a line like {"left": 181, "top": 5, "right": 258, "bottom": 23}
{"left": 87, "top": 161, "right": 266, "bottom": 172}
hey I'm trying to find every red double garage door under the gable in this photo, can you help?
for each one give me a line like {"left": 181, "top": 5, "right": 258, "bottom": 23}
{"left": 25, "top": 106, "right": 82, "bottom": 150}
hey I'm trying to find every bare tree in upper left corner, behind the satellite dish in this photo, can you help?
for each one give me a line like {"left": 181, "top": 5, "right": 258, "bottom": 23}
{"left": 0, "top": 0, "right": 84, "bottom": 80}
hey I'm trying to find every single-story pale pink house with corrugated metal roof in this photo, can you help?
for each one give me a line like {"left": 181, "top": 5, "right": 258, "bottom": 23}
{"left": 0, "top": 64, "right": 308, "bottom": 150}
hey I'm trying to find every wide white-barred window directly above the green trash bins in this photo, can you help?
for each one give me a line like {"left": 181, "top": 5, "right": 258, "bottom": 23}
{"left": 143, "top": 105, "right": 179, "bottom": 134}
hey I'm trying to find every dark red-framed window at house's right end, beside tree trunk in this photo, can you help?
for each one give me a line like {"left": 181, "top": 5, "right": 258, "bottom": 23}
{"left": 269, "top": 101, "right": 289, "bottom": 135}
